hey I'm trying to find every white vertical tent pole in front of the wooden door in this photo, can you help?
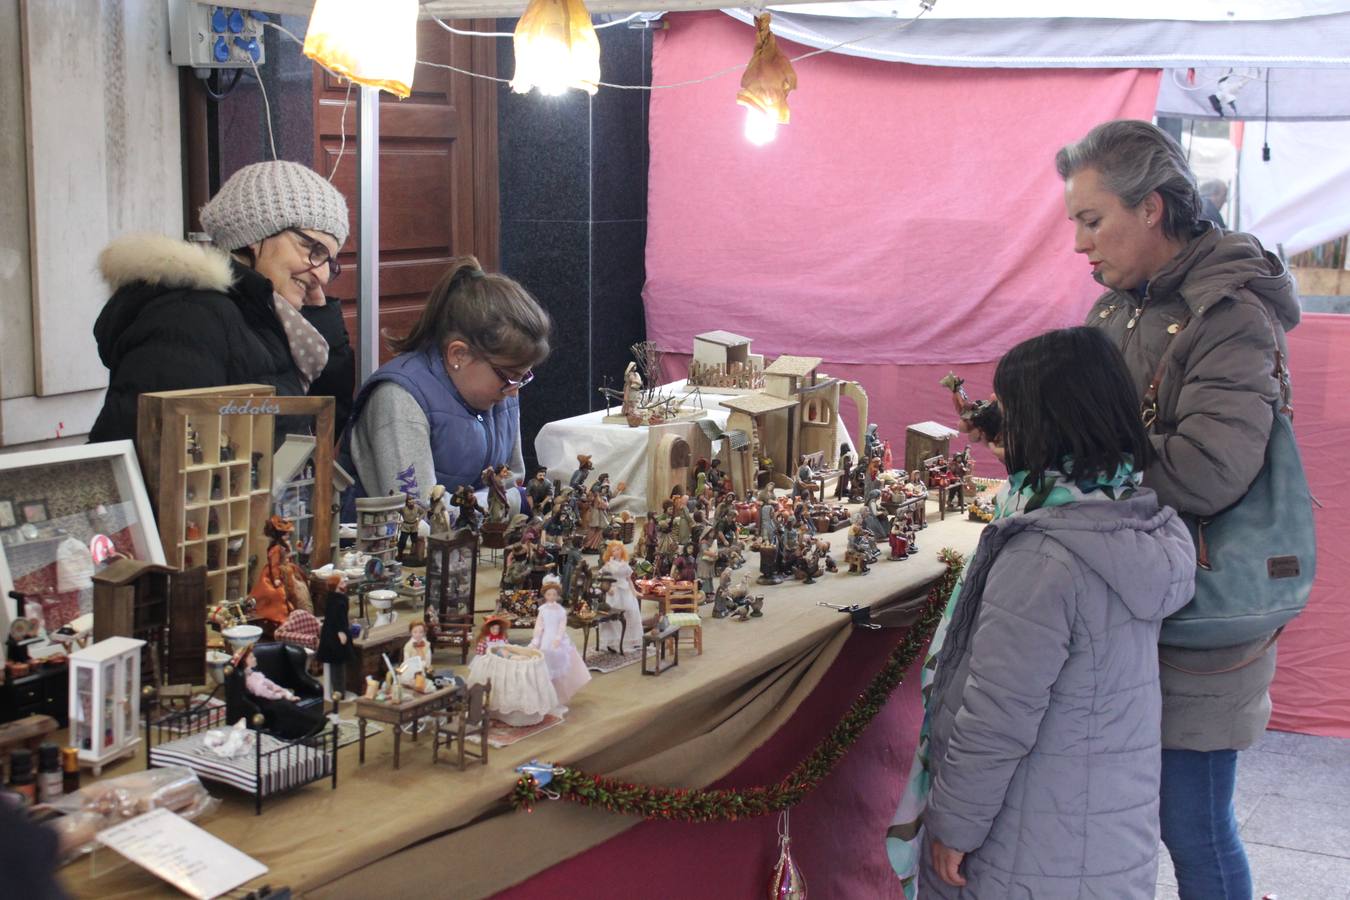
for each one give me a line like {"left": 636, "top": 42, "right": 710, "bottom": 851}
{"left": 356, "top": 85, "right": 379, "bottom": 383}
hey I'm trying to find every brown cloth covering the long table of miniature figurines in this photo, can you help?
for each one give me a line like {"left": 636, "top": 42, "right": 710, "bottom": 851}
{"left": 52, "top": 507, "right": 979, "bottom": 897}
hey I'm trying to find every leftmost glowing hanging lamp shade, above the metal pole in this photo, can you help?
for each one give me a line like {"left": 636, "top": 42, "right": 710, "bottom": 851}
{"left": 305, "top": 0, "right": 417, "bottom": 99}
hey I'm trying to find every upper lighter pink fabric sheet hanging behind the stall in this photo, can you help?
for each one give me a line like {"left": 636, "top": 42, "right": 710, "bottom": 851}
{"left": 644, "top": 12, "right": 1158, "bottom": 366}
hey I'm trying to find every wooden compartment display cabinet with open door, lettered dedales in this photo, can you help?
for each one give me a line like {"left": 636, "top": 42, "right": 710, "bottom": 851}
{"left": 136, "top": 385, "right": 333, "bottom": 614}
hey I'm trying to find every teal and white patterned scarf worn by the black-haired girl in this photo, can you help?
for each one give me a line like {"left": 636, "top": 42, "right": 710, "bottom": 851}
{"left": 886, "top": 456, "right": 1143, "bottom": 900}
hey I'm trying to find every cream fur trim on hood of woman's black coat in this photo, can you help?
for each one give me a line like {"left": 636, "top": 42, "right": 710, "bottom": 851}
{"left": 99, "top": 233, "right": 234, "bottom": 293}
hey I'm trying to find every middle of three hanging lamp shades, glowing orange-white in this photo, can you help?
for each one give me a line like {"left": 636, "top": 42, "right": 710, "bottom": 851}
{"left": 510, "top": 0, "right": 599, "bottom": 94}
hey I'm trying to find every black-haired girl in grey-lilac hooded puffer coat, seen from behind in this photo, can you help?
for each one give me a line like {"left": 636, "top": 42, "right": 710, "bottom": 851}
{"left": 919, "top": 328, "right": 1195, "bottom": 900}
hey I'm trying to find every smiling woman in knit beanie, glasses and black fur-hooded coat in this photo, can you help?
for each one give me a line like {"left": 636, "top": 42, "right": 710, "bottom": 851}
{"left": 89, "top": 161, "right": 355, "bottom": 441}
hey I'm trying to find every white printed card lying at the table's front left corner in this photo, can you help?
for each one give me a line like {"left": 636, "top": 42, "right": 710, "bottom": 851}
{"left": 97, "top": 810, "right": 267, "bottom": 900}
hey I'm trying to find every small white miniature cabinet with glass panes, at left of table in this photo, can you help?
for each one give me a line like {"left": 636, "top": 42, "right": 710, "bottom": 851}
{"left": 70, "top": 637, "right": 146, "bottom": 775}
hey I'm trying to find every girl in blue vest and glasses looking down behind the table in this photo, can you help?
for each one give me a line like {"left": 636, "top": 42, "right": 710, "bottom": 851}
{"left": 340, "top": 256, "right": 552, "bottom": 518}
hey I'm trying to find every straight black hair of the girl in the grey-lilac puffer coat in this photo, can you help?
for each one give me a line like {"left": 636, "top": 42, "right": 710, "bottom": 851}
{"left": 994, "top": 328, "right": 1149, "bottom": 484}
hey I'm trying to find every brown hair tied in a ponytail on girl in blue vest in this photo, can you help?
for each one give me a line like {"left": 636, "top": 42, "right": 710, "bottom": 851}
{"left": 386, "top": 256, "right": 552, "bottom": 366}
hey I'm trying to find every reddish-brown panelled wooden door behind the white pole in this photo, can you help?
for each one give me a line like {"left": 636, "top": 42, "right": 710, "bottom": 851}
{"left": 313, "top": 19, "right": 500, "bottom": 362}
